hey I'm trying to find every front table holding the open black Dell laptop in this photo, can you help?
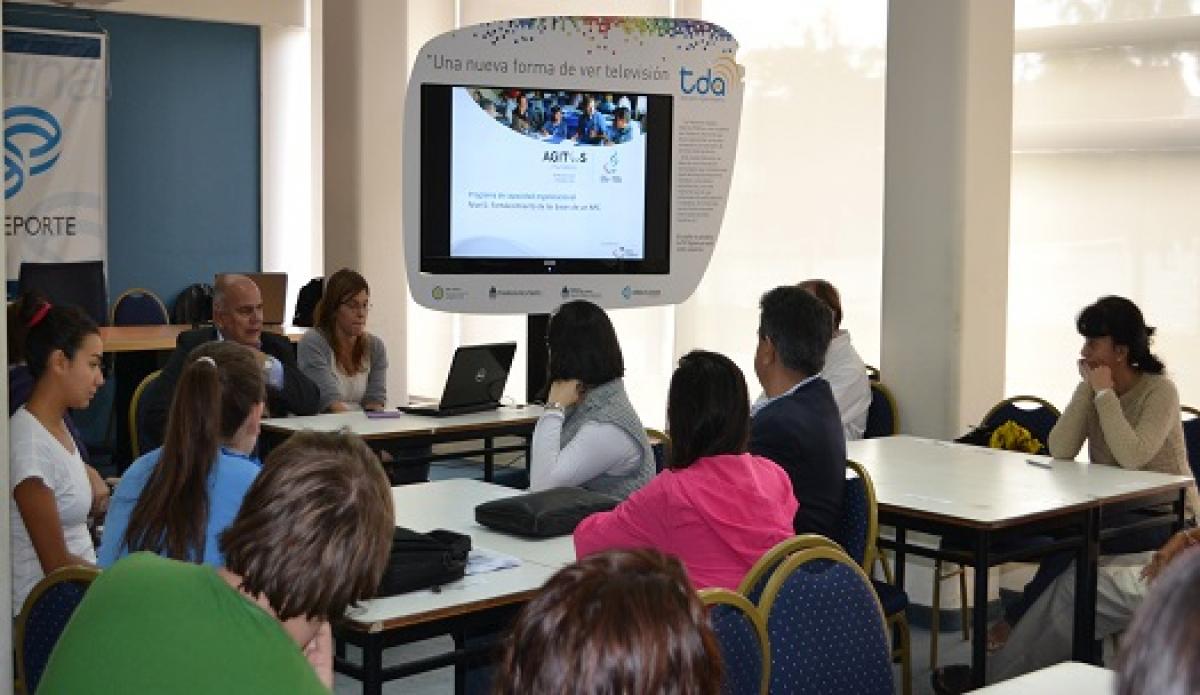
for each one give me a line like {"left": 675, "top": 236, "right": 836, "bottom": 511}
{"left": 259, "top": 406, "right": 542, "bottom": 481}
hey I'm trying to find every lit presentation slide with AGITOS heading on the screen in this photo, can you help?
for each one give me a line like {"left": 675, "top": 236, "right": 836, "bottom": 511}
{"left": 449, "top": 86, "right": 654, "bottom": 260}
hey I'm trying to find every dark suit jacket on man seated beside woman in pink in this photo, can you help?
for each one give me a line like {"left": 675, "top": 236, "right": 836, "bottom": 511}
{"left": 750, "top": 377, "right": 846, "bottom": 538}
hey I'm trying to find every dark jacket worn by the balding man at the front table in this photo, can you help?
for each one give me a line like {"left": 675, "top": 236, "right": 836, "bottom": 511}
{"left": 138, "top": 326, "right": 320, "bottom": 451}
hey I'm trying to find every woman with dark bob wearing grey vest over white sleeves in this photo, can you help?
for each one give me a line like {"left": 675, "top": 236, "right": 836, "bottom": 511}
{"left": 529, "top": 300, "right": 654, "bottom": 499}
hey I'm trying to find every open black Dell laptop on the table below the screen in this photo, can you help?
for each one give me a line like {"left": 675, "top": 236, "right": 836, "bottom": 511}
{"left": 400, "top": 342, "right": 517, "bottom": 418}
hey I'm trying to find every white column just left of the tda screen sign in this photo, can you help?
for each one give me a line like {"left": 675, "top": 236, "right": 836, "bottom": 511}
{"left": 323, "top": 0, "right": 454, "bottom": 402}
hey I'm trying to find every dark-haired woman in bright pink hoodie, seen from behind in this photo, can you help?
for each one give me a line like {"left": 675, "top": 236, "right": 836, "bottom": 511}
{"left": 575, "top": 351, "right": 796, "bottom": 589}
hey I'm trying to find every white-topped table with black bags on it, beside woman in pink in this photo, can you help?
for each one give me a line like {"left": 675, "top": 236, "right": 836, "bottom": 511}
{"left": 334, "top": 479, "right": 575, "bottom": 695}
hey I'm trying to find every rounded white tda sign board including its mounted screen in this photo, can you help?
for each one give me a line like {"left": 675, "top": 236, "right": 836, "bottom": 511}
{"left": 404, "top": 17, "right": 744, "bottom": 313}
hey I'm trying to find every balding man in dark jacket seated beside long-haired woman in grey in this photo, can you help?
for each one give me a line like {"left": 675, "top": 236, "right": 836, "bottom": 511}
{"left": 139, "top": 275, "right": 320, "bottom": 450}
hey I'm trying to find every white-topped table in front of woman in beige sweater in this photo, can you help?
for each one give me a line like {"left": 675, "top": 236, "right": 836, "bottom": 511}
{"left": 846, "top": 436, "right": 1192, "bottom": 687}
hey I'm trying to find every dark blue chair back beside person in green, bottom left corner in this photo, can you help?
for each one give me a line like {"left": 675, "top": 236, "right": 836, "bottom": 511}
{"left": 16, "top": 567, "right": 100, "bottom": 695}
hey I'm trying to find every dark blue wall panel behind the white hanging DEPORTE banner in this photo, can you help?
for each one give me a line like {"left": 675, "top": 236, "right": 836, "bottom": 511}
{"left": 4, "top": 4, "right": 262, "bottom": 307}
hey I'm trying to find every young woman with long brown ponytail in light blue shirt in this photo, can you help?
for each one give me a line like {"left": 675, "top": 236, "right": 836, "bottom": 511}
{"left": 100, "top": 341, "right": 266, "bottom": 568}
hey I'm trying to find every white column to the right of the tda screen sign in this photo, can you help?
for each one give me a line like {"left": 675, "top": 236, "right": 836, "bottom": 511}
{"left": 880, "top": 0, "right": 1013, "bottom": 438}
